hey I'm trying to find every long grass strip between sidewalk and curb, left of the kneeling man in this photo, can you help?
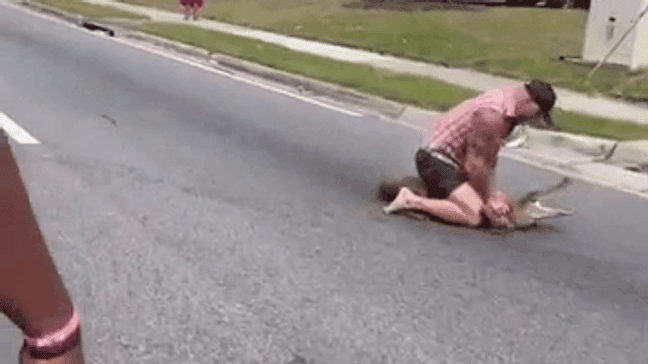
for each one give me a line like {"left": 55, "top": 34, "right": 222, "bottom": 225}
{"left": 144, "top": 23, "right": 477, "bottom": 111}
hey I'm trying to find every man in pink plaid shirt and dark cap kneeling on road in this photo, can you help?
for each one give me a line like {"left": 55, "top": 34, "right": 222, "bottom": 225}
{"left": 384, "top": 80, "right": 556, "bottom": 227}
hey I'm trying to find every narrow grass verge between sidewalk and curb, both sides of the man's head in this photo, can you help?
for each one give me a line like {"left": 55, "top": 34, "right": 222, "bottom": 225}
{"left": 144, "top": 23, "right": 648, "bottom": 140}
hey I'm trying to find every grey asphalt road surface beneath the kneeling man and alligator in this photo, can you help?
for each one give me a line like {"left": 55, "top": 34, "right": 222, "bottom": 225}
{"left": 0, "top": 4, "right": 648, "bottom": 364}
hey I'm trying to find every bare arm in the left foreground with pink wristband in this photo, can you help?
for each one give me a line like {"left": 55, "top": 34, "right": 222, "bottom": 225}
{"left": 0, "top": 130, "right": 83, "bottom": 363}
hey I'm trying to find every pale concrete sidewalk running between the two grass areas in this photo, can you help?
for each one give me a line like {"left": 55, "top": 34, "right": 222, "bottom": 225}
{"left": 74, "top": 0, "right": 648, "bottom": 124}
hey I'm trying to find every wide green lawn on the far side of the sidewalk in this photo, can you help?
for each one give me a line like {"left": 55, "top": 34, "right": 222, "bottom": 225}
{"left": 114, "top": 0, "right": 648, "bottom": 100}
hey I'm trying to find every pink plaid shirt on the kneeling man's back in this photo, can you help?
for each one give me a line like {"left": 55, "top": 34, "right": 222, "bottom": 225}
{"left": 424, "top": 86, "right": 515, "bottom": 167}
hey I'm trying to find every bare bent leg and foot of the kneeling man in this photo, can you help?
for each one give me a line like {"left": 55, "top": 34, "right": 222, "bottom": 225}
{"left": 385, "top": 182, "right": 483, "bottom": 227}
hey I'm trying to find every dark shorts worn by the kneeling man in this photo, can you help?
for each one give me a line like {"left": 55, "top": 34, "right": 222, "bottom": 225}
{"left": 416, "top": 149, "right": 467, "bottom": 199}
